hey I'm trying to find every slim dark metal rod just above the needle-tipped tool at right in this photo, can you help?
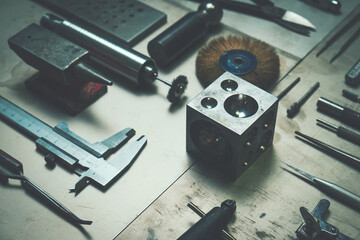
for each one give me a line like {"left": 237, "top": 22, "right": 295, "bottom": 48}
{"left": 295, "top": 131, "right": 360, "bottom": 169}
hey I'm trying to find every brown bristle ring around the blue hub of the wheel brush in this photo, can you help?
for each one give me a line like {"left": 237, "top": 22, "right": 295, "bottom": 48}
{"left": 196, "top": 36, "right": 280, "bottom": 90}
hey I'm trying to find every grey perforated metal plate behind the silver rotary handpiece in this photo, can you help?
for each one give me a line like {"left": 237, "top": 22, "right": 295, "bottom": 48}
{"left": 35, "top": 0, "right": 166, "bottom": 46}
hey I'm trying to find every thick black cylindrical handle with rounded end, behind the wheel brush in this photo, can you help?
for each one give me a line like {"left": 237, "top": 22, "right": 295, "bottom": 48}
{"left": 148, "top": 1, "right": 223, "bottom": 66}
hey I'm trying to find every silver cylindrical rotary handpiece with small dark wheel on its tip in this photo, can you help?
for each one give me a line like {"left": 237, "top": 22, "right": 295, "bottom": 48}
{"left": 40, "top": 14, "right": 188, "bottom": 103}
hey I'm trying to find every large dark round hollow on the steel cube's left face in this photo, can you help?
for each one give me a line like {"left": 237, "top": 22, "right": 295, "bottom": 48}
{"left": 190, "top": 120, "right": 232, "bottom": 162}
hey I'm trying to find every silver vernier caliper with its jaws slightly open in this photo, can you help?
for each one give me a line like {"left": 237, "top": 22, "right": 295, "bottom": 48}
{"left": 0, "top": 96, "right": 147, "bottom": 193}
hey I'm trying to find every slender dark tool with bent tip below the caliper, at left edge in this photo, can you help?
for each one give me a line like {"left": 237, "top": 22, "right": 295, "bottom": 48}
{"left": 0, "top": 149, "right": 92, "bottom": 225}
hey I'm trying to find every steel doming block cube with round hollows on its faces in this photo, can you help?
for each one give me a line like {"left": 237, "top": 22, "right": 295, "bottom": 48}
{"left": 186, "top": 72, "right": 278, "bottom": 179}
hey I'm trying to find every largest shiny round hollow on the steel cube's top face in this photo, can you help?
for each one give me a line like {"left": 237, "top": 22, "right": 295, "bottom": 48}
{"left": 224, "top": 94, "right": 259, "bottom": 118}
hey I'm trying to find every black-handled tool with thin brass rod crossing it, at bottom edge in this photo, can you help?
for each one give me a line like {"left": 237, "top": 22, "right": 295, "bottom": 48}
{"left": 178, "top": 200, "right": 236, "bottom": 240}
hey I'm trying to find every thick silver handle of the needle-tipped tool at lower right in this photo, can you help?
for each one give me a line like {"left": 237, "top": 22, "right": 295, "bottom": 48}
{"left": 313, "top": 177, "right": 360, "bottom": 211}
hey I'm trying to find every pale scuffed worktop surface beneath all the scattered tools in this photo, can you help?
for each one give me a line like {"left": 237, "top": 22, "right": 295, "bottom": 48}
{"left": 0, "top": 0, "right": 360, "bottom": 240}
